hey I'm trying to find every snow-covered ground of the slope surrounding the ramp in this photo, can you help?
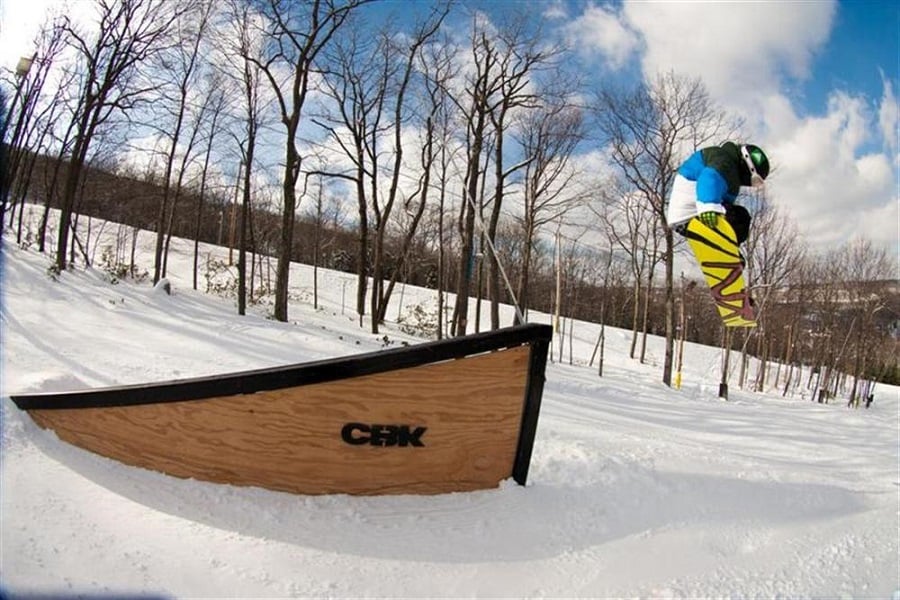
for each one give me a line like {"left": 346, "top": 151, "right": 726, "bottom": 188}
{"left": 0, "top": 212, "right": 900, "bottom": 598}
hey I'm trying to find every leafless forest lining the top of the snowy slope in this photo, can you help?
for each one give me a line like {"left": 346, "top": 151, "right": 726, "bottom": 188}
{"left": 0, "top": 0, "right": 900, "bottom": 406}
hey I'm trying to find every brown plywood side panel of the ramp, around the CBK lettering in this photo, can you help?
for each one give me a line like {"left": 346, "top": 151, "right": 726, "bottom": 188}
{"left": 29, "top": 345, "right": 530, "bottom": 494}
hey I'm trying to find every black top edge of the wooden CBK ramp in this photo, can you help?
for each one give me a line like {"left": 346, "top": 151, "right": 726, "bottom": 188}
{"left": 10, "top": 324, "right": 552, "bottom": 412}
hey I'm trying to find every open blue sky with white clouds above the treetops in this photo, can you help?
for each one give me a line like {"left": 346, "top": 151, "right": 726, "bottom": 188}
{"left": 0, "top": 0, "right": 900, "bottom": 255}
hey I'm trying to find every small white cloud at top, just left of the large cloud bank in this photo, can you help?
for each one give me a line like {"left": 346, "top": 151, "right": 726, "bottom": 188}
{"left": 565, "top": 4, "right": 640, "bottom": 69}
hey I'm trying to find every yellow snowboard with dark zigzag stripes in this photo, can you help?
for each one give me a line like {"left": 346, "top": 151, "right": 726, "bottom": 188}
{"left": 685, "top": 215, "right": 756, "bottom": 327}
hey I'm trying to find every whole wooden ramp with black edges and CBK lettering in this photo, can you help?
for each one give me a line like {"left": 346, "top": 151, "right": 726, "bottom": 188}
{"left": 12, "top": 325, "right": 551, "bottom": 494}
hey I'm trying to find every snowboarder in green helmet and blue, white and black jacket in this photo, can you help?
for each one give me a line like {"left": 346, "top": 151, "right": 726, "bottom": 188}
{"left": 666, "top": 142, "right": 769, "bottom": 244}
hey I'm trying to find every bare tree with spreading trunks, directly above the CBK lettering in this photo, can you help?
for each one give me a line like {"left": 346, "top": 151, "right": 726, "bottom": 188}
{"left": 317, "top": 4, "right": 449, "bottom": 333}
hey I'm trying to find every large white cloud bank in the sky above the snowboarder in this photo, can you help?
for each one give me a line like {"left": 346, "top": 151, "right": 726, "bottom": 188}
{"left": 569, "top": 0, "right": 900, "bottom": 251}
